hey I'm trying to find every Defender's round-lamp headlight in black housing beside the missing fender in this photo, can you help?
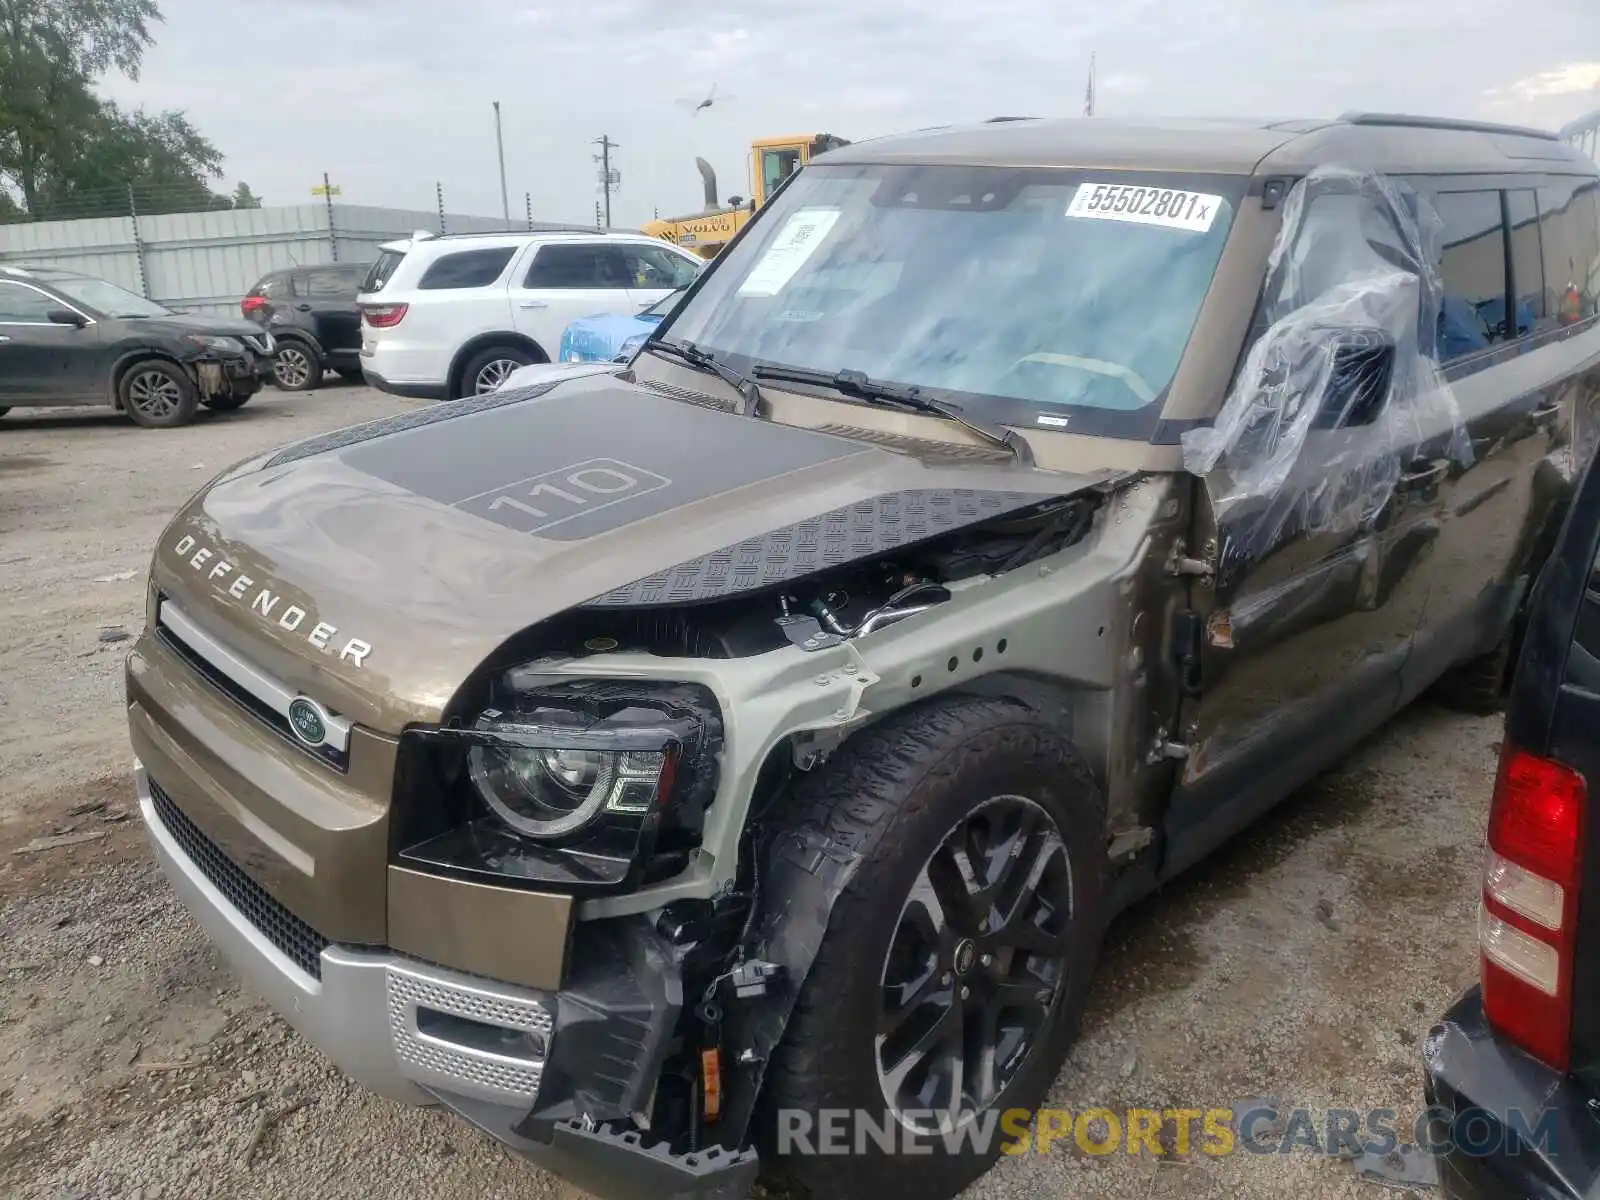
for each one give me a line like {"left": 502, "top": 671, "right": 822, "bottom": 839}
{"left": 397, "top": 672, "right": 722, "bottom": 891}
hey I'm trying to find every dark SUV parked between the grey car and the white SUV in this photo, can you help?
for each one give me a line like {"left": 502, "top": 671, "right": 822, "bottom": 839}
{"left": 238, "top": 262, "right": 373, "bottom": 392}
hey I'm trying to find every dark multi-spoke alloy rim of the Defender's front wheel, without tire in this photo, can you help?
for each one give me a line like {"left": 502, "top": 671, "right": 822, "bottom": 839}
{"left": 877, "top": 795, "right": 1074, "bottom": 1133}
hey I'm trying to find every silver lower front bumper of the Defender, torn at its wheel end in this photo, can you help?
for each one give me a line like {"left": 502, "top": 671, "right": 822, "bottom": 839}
{"left": 134, "top": 765, "right": 758, "bottom": 1200}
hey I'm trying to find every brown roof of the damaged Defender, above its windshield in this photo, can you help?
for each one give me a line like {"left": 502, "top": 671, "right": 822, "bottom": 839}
{"left": 818, "top": 114, "right": 1597, "bottom": 174}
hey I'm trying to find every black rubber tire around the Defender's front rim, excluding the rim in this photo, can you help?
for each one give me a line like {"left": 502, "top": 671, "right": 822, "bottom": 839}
{"left": 757, "top": 698, "right": 1106, "bottom": 1200}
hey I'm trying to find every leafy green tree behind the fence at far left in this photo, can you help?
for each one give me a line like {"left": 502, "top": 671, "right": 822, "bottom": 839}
{"left": 0, "top": 0, "right": 234, "bottom": 219}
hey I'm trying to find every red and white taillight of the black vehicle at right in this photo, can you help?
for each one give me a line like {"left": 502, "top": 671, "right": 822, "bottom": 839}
{"left": 1478, "top": 742, "right": 1587, "bottom": 1070}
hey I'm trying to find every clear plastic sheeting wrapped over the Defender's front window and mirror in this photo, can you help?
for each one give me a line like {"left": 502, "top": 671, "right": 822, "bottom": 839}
{"left": 1182, "top": 168, "right": 1472, "bottom": 562}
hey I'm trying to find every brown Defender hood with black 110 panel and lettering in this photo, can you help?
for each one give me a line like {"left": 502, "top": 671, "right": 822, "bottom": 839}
{"left": 150, "top": 373, "right": 1096, "bottom": 733}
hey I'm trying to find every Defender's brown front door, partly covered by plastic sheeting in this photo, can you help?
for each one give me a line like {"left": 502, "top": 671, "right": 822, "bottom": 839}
{"left": 1166, "top": 180, "right": 1448, "bottom": 870}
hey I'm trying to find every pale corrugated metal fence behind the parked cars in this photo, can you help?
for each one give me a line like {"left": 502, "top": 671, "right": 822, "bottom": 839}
{"left": 0, "top": 178, "right": 594, "bottom": 314}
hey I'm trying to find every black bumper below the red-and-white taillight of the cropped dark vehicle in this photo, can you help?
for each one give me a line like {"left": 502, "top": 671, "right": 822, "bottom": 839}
{"left": 1422, "top": 987, "right": 1600, "bottom": 1200}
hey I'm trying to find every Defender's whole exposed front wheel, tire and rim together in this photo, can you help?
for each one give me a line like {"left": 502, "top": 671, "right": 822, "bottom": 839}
{"left": 763, "top": 698, "right": 1106, "bottom": 1200}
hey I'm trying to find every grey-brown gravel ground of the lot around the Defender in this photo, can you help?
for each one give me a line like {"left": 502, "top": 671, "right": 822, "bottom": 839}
{"left": 0, "top": 384, "right": 1499, "bottom": 1200}
